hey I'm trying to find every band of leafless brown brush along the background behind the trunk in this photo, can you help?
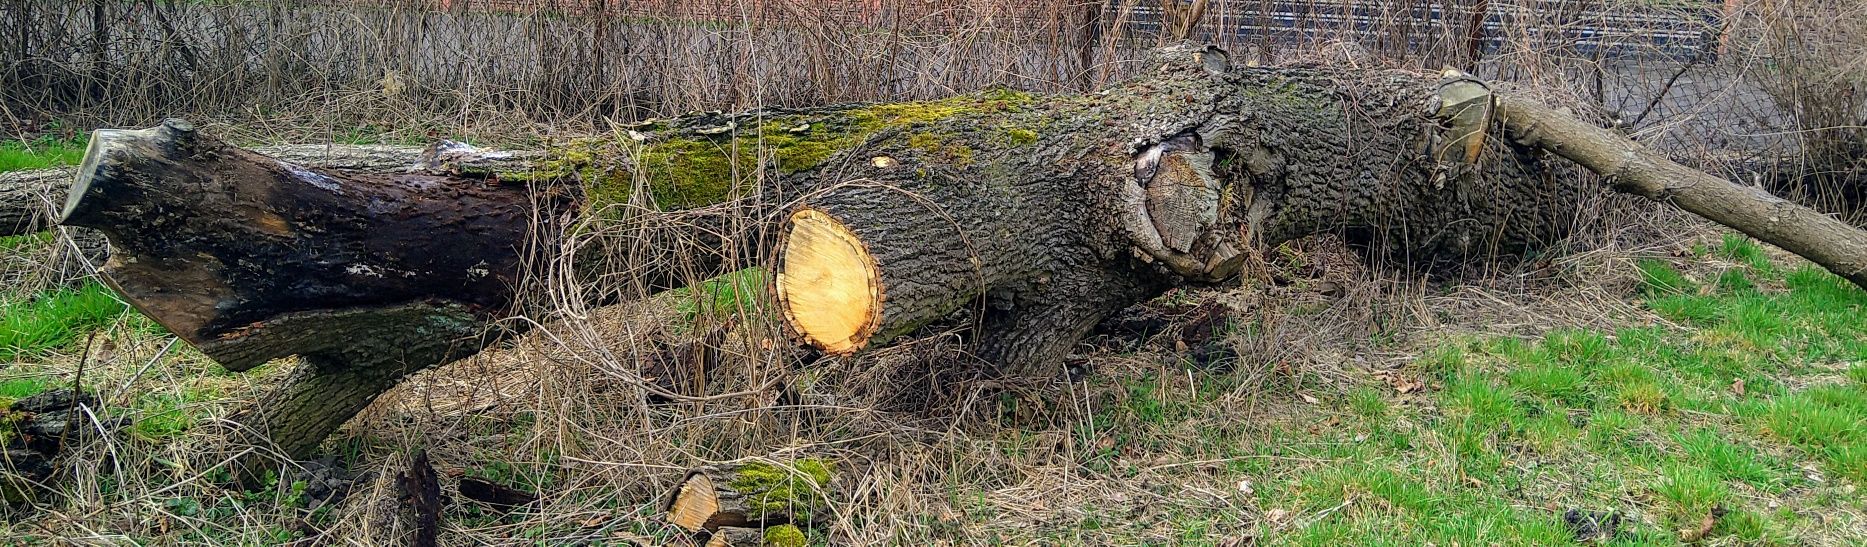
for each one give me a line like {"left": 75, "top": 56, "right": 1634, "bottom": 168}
{"left": 0, "top": 0, "right": 1732, "bottom": 140}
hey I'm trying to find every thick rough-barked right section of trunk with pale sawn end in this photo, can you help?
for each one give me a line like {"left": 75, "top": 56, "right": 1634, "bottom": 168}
{"left": 775, "top": 49, "right": 1591, "bottom": 373}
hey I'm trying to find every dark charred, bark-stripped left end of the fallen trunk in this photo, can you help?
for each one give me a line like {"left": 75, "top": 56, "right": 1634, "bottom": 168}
{"left": 60, "top": 121, "right": 569, "bottom": 365}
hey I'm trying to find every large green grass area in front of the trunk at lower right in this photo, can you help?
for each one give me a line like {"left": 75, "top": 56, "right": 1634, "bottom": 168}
{"left": 1052, "top": 237, "right": 1867, "bottom": 545}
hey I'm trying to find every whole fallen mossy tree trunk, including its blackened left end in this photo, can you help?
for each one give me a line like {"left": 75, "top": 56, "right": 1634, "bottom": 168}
{"left": 63, "top": 47, "right": 1858, "bottom": 456}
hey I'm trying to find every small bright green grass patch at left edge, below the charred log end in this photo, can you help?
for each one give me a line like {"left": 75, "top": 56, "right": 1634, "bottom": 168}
{"left": 0, "top": 284, "right": 127, "bottom": 362}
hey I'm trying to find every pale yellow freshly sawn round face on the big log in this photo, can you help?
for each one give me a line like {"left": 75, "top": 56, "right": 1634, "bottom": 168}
{"left": 777, "top": 209, "right": 883, "bottom": 355}
